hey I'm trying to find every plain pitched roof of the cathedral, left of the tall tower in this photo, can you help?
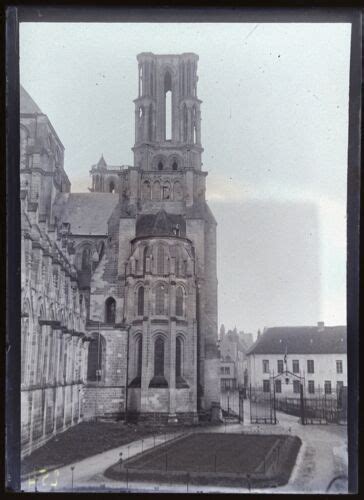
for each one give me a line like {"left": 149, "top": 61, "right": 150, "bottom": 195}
{"left": 54, "top": 193, "right": 119, "bottom": 236}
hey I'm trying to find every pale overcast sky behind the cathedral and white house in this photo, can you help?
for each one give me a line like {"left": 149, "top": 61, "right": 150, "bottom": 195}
{"left": 20, "top": 23, "right": 350, "bottom": 333}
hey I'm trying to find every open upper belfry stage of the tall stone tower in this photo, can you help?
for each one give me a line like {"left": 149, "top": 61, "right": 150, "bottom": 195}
{"left": 133, "top": 52, "right": 203, "bottom": 170}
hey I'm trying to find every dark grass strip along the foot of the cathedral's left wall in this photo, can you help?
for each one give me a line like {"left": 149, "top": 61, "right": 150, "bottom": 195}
{"left": 21, "top": 422, "right": 179, "bottom": 475}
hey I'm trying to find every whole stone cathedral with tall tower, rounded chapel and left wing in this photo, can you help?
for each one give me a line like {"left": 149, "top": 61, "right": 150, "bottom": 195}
{"left": 20, "top": 53, "right": 220, "bottom": 455}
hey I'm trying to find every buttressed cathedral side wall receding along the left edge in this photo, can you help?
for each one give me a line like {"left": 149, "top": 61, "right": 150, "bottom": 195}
{"left": 20, "top": 88, "right": 88, "bottom": 455}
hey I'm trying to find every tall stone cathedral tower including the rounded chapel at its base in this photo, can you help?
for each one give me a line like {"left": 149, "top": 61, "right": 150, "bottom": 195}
{"left": 118, "top": 53, "right": 220, "bottom": 421}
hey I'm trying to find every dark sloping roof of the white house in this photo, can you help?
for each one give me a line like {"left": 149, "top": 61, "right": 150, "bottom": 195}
{"left": 247, "top": 326, "right": 347, "bottom": 355}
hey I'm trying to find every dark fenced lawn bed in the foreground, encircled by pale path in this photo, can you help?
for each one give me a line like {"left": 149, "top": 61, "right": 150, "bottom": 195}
{"left": 104, "top": 433, "right": 301, "bottom": 488}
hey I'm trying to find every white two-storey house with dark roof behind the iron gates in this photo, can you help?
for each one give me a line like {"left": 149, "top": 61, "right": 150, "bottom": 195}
{"left": 247, "top": 322, "right": 347, "bottom": 397}
